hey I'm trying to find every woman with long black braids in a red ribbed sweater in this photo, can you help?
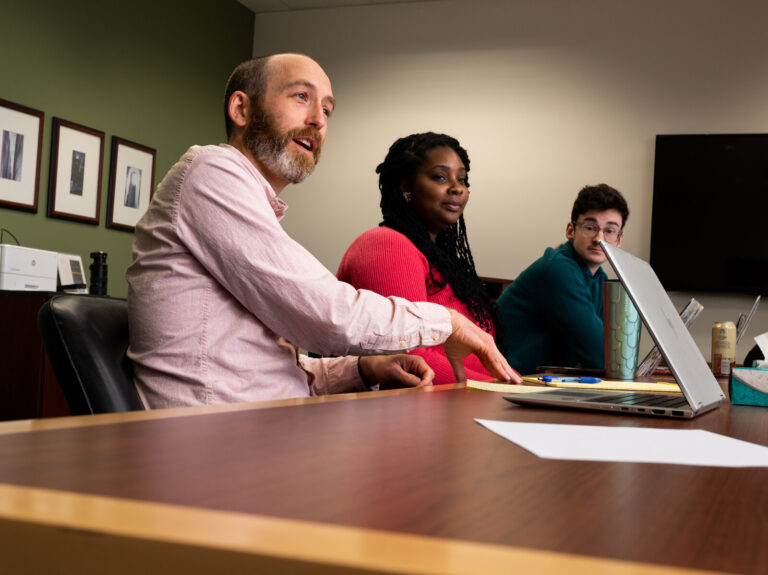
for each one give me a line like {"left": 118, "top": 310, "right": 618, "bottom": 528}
{"left": 337, "top": 132, "right": 499, "bottom": 384}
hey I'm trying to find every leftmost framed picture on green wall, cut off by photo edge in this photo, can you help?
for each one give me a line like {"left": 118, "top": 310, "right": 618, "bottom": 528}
{"left": 0, "top": 99, "right": 44, "bottom": 212}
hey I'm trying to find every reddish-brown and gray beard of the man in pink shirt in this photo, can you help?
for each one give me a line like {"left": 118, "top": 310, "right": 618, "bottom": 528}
{"left": 244, "top": 114, "right": 315, "bottom": 184}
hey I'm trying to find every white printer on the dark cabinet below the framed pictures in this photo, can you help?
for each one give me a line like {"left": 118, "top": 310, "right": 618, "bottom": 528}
{"left": 0, "top": 244, "right": 58, "bottom": 291}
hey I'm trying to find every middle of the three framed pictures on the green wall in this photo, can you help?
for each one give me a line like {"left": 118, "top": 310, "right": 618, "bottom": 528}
{"left": 48, "top": 118, "right": 104, "bottom": 225}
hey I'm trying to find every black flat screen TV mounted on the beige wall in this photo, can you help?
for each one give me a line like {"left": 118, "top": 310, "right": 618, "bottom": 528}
{"left": 650, "top": 134, "right": 768, "bottom": 295}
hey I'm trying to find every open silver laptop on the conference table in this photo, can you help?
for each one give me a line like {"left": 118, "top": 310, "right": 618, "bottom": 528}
{"left": 504, "top": 241, "right": 725, "bottom": 418}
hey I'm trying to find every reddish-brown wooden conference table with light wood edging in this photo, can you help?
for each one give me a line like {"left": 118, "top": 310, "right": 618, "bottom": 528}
{"left": 0, "top": 385, "right": 768, "bottom": 574}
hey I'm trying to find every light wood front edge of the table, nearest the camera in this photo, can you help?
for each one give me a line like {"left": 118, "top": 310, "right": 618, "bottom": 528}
{"left": 0, "top": 483, "right": 720, "bottom": 575}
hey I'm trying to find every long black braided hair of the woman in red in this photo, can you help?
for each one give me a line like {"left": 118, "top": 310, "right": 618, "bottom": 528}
{"left": 376, "top": 132, "right": 501, "bottom": 337}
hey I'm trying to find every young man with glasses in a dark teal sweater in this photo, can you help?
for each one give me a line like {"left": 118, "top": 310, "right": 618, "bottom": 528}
{"left": 497, "top": 184, "right": 629, "bottom": 374}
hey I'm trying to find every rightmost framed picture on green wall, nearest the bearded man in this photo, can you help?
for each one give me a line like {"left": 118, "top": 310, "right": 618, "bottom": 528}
{"left": 107, "top": 136, "right": 155, "bottom": 232}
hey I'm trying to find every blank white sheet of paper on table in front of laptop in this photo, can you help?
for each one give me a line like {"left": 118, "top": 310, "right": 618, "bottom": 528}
{"left": 475, "top": 419, "right": 768, "bottom": 467}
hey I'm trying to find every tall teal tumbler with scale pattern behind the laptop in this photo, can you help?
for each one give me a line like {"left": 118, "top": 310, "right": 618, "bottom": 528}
{"left": 603, "top": 280, "right": 643, "bottom": 380}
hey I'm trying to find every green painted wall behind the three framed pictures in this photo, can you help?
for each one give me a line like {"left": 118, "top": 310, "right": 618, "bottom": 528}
{"left": 0, "top": 0, "right": 254, "bottom": 297}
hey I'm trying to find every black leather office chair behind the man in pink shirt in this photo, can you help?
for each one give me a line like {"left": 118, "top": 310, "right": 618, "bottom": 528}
{"left": 37, "top": 294, "right": 144, "bottom": 415}
